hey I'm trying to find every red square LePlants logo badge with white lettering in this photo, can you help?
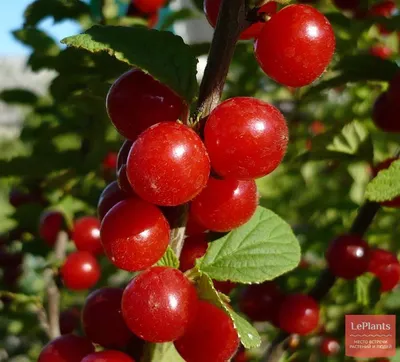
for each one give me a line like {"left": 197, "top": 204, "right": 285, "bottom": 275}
{"left": 346, "top": 315, "right": 396, "bottom": 358}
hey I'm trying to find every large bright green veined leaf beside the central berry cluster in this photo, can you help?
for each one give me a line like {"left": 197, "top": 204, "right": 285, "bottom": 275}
{"left": 198, "top": 207, "right": 300, "bottom": 283}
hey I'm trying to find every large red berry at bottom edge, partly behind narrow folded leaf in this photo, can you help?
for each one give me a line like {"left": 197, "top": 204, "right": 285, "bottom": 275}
{"left": 174, "top": 300, "right": 239, "bottom": 362}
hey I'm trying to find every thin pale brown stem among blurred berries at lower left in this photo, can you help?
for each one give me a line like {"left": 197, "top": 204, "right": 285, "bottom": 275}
{"left": 38, "top": 231, "right": 69, "bottom": 339}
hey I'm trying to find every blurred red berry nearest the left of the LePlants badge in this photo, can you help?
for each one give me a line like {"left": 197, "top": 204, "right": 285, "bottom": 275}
{"left": 278, "top": 294, "right": 319, "bottom": 335}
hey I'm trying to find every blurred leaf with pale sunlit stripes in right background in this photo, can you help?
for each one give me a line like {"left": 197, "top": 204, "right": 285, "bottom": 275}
{"left": 299, "top": 121, "right": 374, "bottom": 162}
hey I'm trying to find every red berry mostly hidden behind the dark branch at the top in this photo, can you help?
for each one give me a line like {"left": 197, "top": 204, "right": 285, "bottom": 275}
{"left": 204, "top": 0, "right": 278, "bottom": 40}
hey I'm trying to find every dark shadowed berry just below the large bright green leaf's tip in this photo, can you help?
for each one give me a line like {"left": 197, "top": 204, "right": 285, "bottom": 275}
{"left": 239, "top": 281, "right": 283, "bottom": 322}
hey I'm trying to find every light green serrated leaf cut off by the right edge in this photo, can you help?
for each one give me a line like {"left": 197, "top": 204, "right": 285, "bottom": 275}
{"left": 365, "top": 160, "right": 400, "bottom": 202}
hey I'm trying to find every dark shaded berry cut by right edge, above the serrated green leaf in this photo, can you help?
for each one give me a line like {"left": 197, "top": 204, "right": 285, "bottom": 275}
{"left": 372, "top": 92, "right": 400, "bottom": 133}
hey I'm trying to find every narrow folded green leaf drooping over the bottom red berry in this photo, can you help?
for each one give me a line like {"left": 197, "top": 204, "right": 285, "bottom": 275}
{"left": 197, "top": 273, "right": 261, "bottom": 348}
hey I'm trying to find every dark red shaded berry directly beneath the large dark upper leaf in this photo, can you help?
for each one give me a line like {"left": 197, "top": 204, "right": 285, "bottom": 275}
{"left": 106, "top": 68, "right": 183, "bottom": 141}
